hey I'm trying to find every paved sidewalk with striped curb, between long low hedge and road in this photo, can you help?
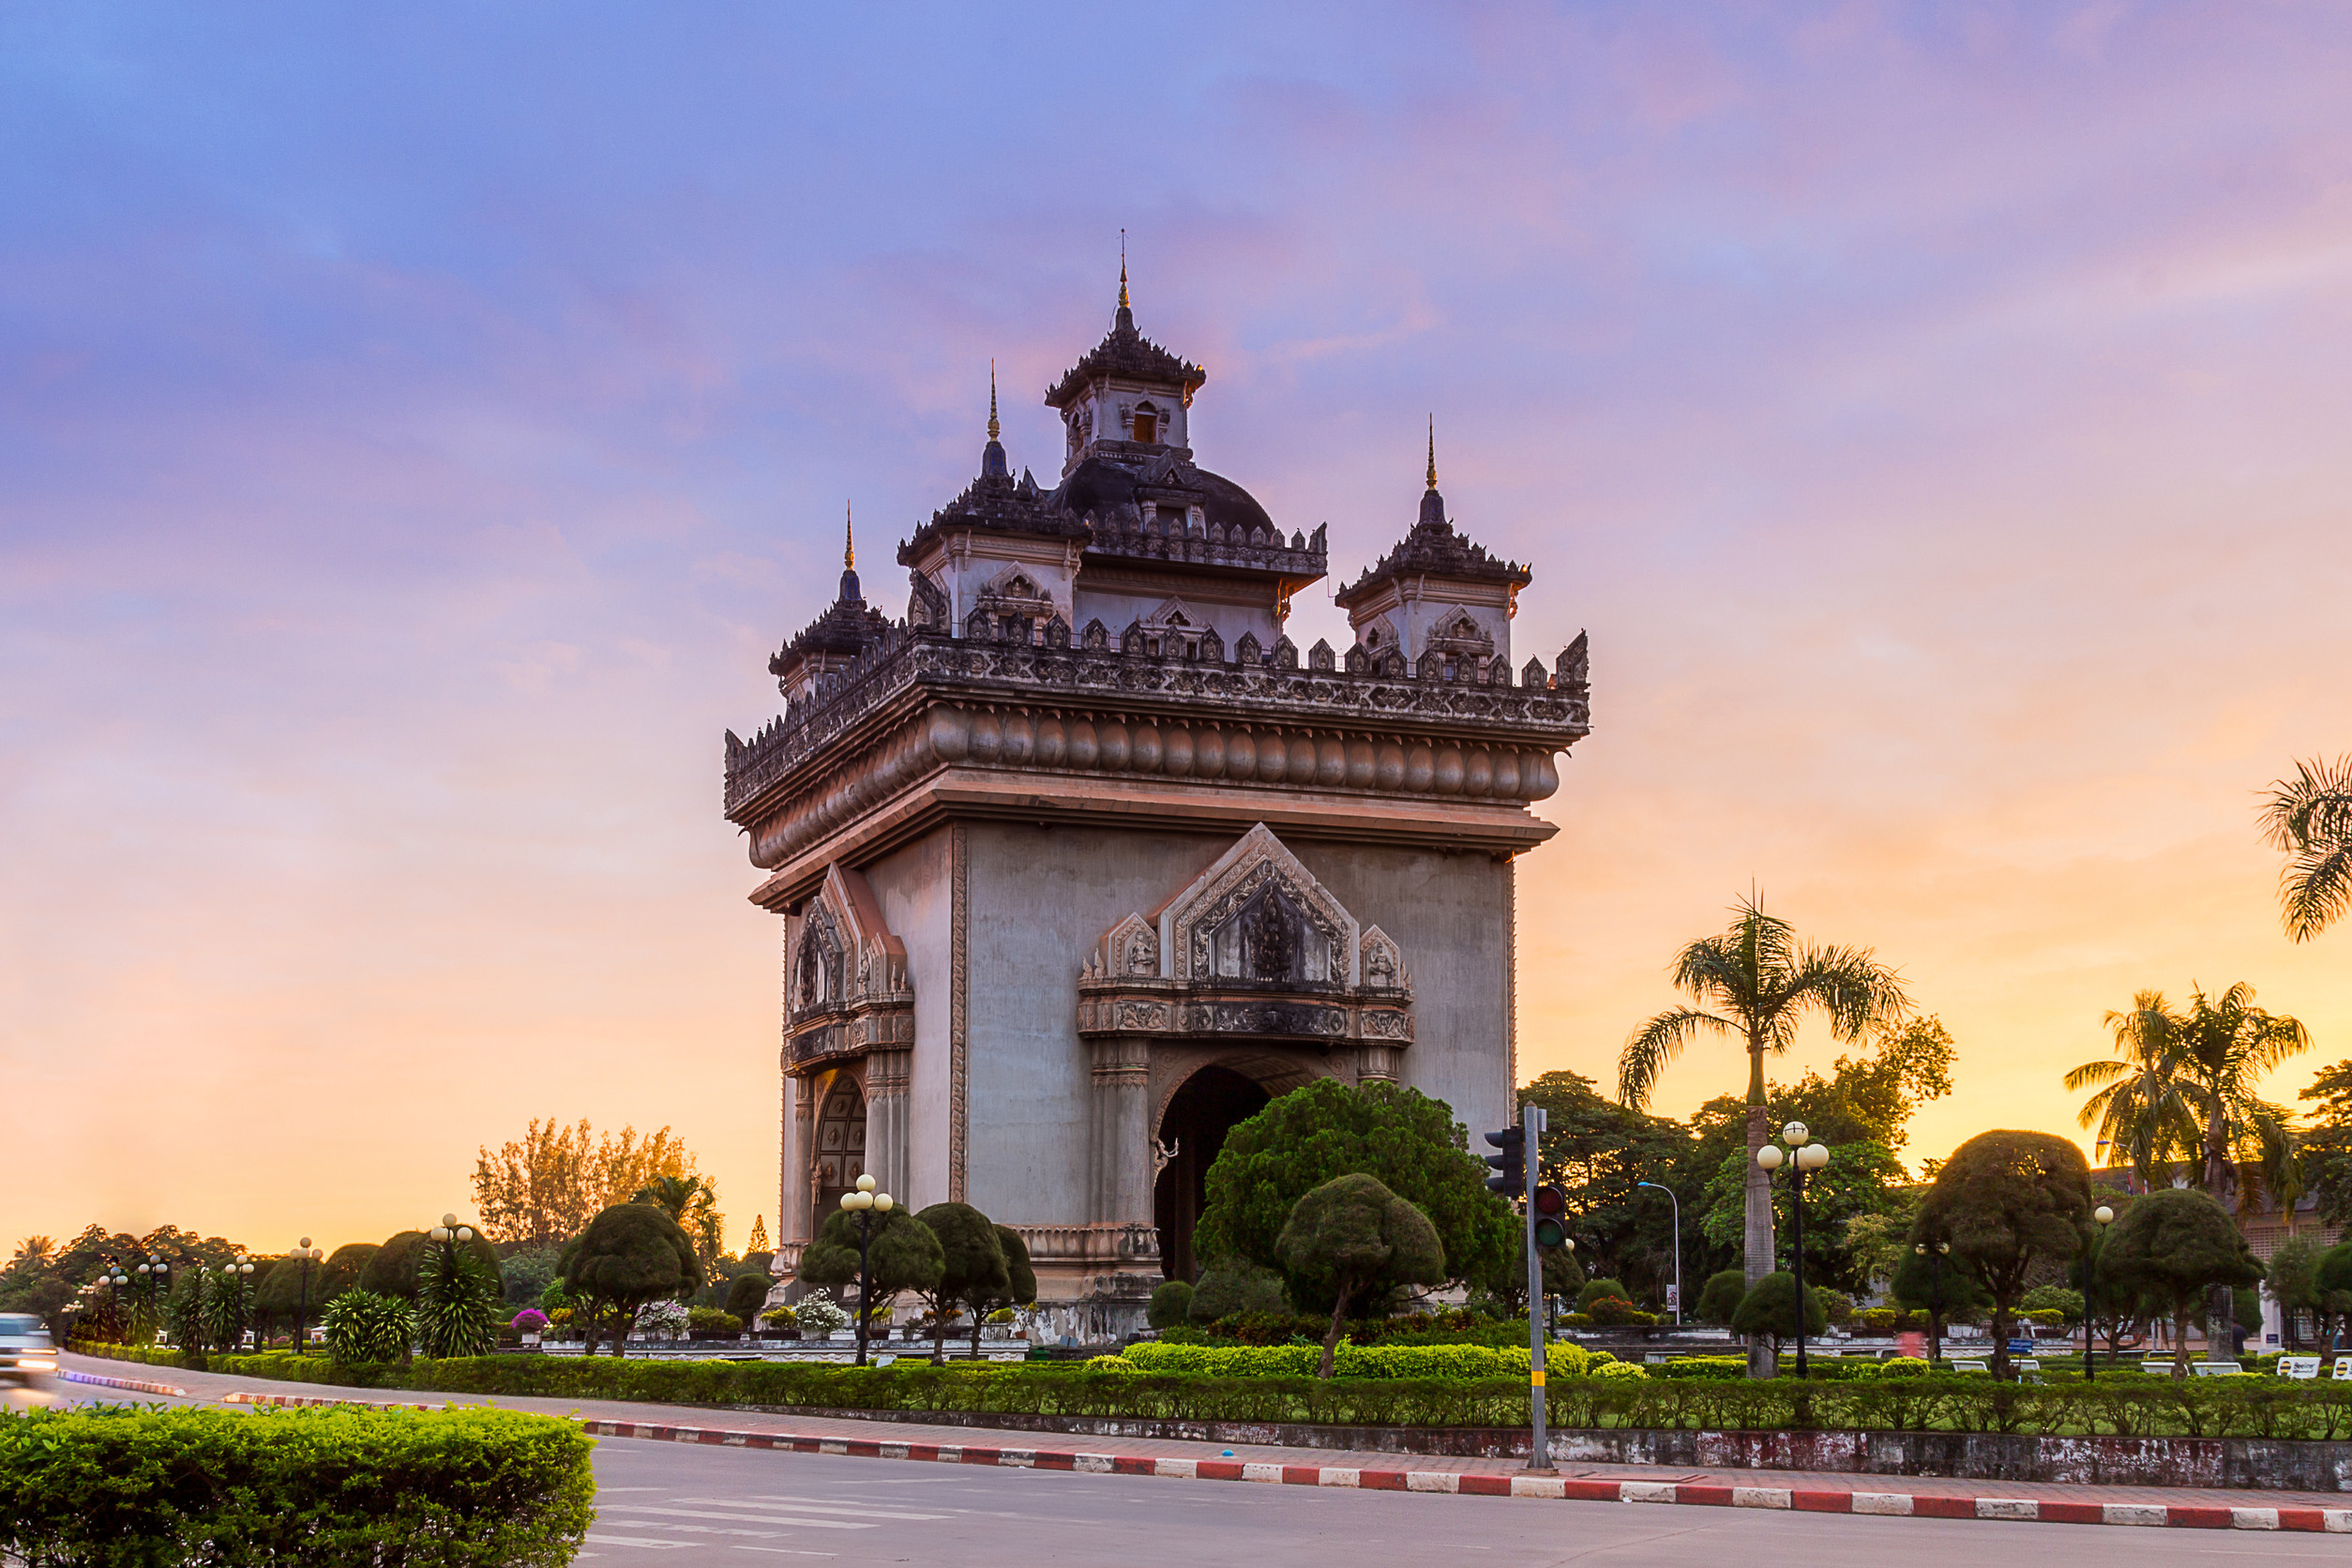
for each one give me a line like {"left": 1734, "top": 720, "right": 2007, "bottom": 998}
{"left": 68, "top": 1356, "right": 2352, "bottom": 1532}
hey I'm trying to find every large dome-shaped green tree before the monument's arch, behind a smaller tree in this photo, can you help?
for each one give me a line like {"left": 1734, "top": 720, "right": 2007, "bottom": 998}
{"left": 1193, "top": 1079, "right": 1519, "bottom": 1304}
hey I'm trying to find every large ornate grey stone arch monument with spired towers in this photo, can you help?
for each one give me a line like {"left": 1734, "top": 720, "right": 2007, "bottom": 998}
{"left": 727, "top": 268, "right": 1588, "bottom": 1337}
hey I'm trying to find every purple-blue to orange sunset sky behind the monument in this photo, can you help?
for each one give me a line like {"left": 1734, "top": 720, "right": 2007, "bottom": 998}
{"left": 0, "top": 0, "right": 2352, "bottom": 1258}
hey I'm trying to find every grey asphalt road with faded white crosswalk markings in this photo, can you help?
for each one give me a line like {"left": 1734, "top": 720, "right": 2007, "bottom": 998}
{"left": 0, "top": 1373, "right": 2347, "bottom": 1568}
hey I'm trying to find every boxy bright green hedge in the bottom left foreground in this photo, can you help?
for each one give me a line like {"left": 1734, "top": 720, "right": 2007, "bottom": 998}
{"left": 0, "top": 1406, "right": 596, "bottom": 1568}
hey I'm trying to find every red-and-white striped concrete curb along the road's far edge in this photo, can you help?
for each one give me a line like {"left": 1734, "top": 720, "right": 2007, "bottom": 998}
{"left": 202, "top": 1395, "right": 2352, "bottom": 1535}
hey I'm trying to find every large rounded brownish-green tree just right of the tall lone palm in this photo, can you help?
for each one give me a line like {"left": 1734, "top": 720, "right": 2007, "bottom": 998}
{"left": 1912, "top": 1131, "right": 2091, "bottom": 1378}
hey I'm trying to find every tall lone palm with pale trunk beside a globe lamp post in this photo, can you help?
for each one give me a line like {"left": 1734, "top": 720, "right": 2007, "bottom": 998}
{"left": 1619, "top": 896, "right": 1909, "bottom": 1375}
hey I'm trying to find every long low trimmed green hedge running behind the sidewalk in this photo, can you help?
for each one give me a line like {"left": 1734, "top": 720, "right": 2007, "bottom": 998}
{"left": 73, "top": 1354, "right": 2352, "bottom": 1441}
